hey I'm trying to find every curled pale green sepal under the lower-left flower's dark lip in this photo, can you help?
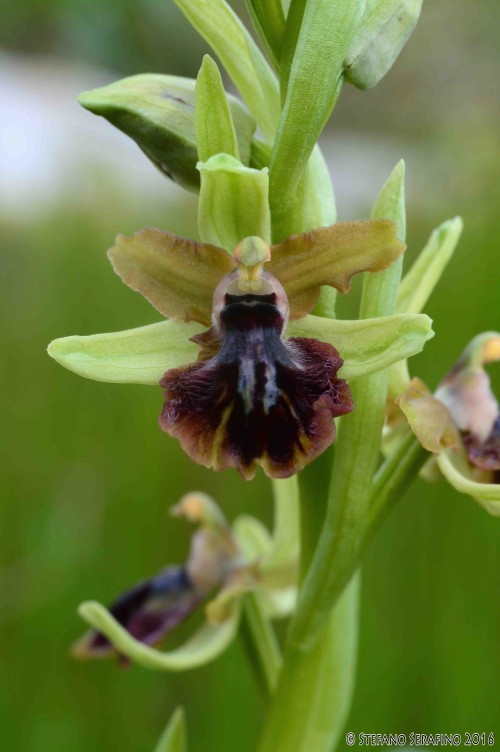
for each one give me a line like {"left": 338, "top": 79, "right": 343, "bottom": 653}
{"left": 78, "top": 601, "right": 240, "bottom": 671}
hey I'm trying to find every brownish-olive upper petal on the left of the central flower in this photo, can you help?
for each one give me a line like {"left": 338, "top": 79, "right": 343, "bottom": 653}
{"left": 108, "top": 229, "right": 235, "bottom": 326}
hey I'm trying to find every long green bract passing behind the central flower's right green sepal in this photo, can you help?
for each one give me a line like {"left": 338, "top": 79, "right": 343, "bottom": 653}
{"left": 289, "top": 163, "right": 405, "bottom": 646}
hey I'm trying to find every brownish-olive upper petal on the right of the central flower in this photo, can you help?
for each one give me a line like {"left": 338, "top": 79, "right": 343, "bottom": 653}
{"left": 267, "top": 219, "right": 405, "bottom": 319}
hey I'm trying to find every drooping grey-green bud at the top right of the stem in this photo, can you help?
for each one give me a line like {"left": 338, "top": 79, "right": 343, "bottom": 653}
{"left": 344, "top": 0, "right": 422, "bottom": 89}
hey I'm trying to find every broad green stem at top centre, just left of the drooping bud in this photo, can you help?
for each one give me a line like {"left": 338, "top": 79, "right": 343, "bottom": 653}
{"left": 269, "top": 0, "right": 364, "bottom": 215}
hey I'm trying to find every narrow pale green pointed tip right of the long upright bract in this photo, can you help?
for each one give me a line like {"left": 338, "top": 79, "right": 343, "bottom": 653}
{"left": 397, "top": 217, "right": 463, "bottom": 313}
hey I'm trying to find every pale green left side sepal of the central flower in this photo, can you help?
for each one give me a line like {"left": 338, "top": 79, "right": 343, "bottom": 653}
{"left": 48, "top": 320, "right": 203, "bottom": 386}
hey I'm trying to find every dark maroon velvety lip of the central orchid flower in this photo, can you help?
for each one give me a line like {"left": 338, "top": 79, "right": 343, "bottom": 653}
{"left": 160, "top": 294, "right": 353, "bottom": 479}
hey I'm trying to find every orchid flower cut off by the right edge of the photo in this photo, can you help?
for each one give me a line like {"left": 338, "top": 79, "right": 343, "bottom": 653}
{"left": 398, "top": 332, "right": 500, "bottom": 516}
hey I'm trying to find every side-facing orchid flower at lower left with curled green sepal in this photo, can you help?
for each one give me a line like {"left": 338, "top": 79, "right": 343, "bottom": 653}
{"left": 73, "top": 493, "right": 298, "bottom": 671}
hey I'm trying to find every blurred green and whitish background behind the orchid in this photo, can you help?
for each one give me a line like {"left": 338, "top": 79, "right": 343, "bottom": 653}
{"left": 0, "top": 0, "right": 500, "bottom": 752}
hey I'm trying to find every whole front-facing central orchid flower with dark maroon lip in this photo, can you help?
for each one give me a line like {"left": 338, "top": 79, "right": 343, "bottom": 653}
{"left": 49, "top": 220, "right": 432, "bottom": 479}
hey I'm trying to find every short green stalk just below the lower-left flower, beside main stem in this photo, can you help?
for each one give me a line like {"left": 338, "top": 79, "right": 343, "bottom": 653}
{"left": 243, "top": 593, "right": 282, "bottom": 697}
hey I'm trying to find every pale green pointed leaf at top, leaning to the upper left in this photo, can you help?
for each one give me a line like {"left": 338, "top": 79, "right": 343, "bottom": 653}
{"left": 175, "top": 0, "right": 280, "bottom": 141}
